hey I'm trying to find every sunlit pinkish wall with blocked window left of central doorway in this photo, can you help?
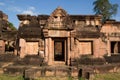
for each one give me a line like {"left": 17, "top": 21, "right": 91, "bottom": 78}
{"left": 17, "top": 38, "right": 44, "bottom": 58}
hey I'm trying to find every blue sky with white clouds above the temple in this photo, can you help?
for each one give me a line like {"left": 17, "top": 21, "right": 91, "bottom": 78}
{"left": 0, "top": 0, "right": 120, "bottom": 28}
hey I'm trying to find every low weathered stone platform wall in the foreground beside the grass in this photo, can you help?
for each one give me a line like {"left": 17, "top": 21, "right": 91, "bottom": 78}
{"left": 4, "top": 64, "right": 120, "bottom": 80}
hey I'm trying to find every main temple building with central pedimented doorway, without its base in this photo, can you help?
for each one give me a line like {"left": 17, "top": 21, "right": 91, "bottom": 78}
{"left": 15, "top": 7, "right": 120, "bottom": 65}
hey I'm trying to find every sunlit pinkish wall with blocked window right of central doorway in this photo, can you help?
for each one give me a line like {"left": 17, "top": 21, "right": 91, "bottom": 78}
{"left": 74, "top": 38, "right": 107, "bottom": 57}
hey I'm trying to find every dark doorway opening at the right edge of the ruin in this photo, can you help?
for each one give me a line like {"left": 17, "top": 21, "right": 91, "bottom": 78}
{"left": 111, "top": 41, "right": 120, "bottom": 54}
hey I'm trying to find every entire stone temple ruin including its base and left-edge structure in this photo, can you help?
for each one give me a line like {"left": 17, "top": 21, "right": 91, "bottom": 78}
{"left": 0, "top": 7, "right": 120, "bottom": 77}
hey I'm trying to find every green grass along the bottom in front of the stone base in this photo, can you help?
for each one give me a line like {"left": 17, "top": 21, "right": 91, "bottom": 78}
{"left": 0, "top": 73, "right": 120, "bottom": 80}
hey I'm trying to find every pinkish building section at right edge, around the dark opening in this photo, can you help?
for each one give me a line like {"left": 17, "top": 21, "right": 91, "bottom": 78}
{"left": 101, "top": 20, "right": 120, "bottom": 56}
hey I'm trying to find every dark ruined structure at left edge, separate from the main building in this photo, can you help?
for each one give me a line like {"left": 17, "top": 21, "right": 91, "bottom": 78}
{"left": 0, "top": 11, "right": 17, "bottom": 54}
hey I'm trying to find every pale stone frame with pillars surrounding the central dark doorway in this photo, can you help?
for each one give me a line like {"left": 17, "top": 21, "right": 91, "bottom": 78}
{"left": 45, "top": 37, "right": 70, "bottom": 65}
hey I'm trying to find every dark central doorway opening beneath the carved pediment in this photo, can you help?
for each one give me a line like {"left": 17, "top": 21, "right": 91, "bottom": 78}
{"left": 54, "top": 40, "right": 65, "bottom": 61}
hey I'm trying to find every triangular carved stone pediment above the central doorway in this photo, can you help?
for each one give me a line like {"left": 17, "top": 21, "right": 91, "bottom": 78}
{"left": 46, "top": 7, "right": 72, "bottom": 29}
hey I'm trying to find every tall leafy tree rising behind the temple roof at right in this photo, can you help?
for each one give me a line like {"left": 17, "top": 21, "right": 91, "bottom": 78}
{"left": 93, "top": 0, "right": 118, "bottom": 22}
